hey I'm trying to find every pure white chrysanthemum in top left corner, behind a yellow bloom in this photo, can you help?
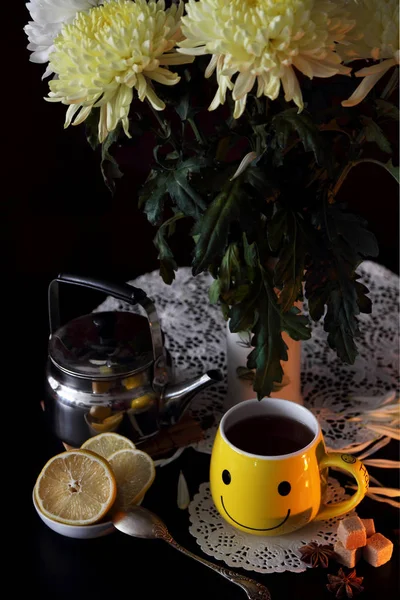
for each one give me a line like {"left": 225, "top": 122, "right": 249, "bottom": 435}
{"left": 24, "top": 0, "right": 102, "bottom": 78}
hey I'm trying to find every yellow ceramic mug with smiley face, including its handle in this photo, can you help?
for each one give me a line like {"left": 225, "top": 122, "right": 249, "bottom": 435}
{"left": 210, "top": 398, "right": 369, "bottom": 536}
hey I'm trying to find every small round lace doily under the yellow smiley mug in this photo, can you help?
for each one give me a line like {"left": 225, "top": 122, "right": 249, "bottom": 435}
{"left": 189, "top": 478, "right": 356, "bottom": 573}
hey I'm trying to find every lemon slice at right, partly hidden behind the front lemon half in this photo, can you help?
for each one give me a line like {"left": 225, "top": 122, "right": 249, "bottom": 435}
{"left": 108, "top": 449, "right": 156, "bottom": 510}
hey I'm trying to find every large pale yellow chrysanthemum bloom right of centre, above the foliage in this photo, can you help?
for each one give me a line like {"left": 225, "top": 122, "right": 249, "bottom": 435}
{"left": 178, "top": 0, "right": 354, "bottom": 118}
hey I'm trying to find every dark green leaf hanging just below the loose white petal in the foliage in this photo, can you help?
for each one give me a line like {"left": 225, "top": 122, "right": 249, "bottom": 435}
{"left": 193, "top": 179, "right": 242, "bottom": 275}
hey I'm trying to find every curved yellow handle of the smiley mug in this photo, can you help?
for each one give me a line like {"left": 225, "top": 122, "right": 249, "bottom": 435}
{"left": 315, "top": 452, "right": 369, "bottom": 521}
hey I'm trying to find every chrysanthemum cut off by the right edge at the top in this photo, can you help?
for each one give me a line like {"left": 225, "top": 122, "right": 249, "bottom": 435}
{"left": 342, "top": 0, "right": 400, "bottom": 106}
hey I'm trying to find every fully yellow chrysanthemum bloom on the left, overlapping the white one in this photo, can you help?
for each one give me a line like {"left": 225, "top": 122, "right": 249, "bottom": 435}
{"left": 47, "top": 0, "right": 193, "bottom": 142}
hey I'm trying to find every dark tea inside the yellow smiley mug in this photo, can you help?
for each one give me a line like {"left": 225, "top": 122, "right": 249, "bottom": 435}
{"left": 225, "top": 415, "right": 314, "bottom": 456}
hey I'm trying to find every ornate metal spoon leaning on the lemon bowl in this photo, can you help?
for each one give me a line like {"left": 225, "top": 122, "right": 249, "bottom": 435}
{"left": 113, "top": 506, "right": 271, "bottom": 600}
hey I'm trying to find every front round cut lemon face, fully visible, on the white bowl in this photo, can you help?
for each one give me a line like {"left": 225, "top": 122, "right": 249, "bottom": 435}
{"left": 34, "top": 450, "right": 117, "bottom": 525}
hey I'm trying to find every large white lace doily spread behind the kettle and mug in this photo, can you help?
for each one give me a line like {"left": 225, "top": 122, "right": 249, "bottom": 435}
{"left": 95, "top": 261, "right": 399, "bottom": 453}
